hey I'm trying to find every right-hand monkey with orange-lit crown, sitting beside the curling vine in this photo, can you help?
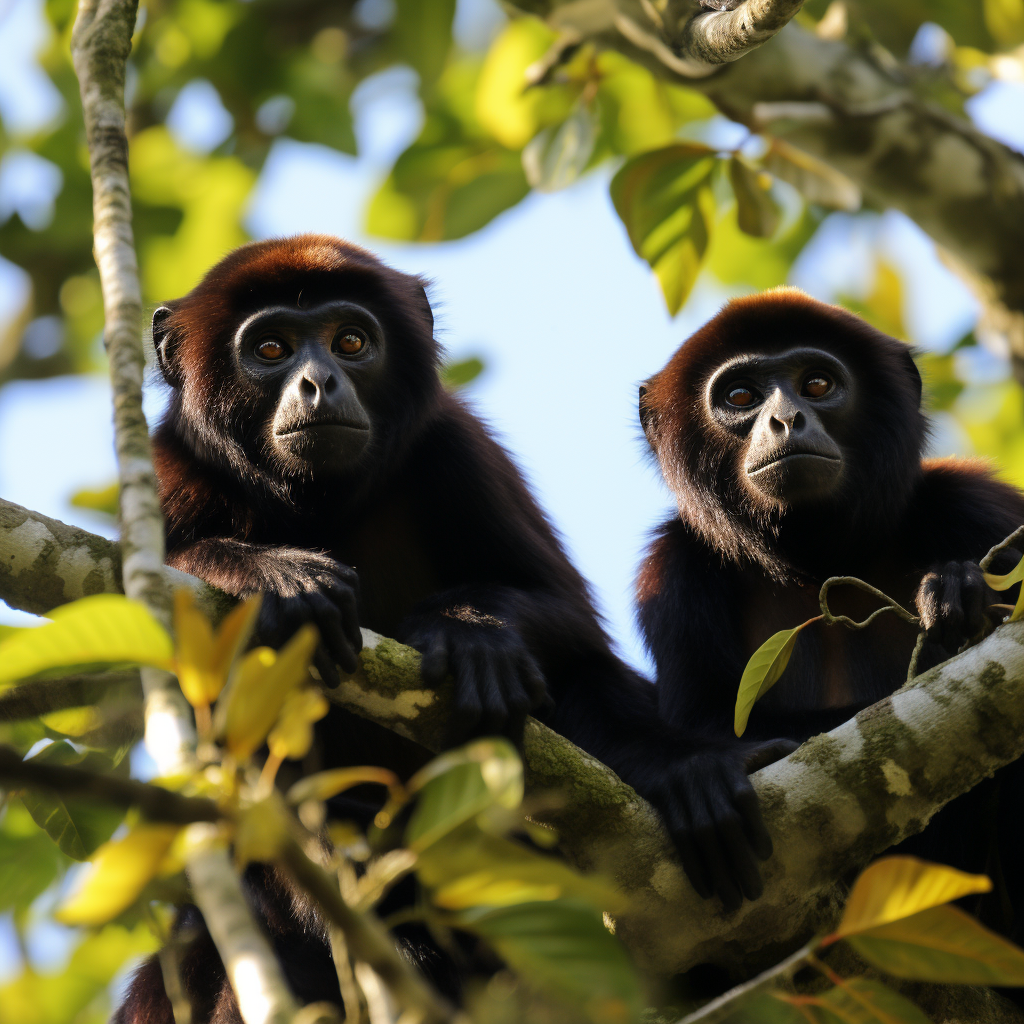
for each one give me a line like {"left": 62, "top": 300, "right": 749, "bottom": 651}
{"left": 637, "top": 289, "right": 1024, "bottom": 911}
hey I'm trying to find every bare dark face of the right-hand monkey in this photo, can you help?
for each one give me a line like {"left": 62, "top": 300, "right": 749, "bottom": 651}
{"left": 706, "top": 346, "right": 854, "bottom": 507}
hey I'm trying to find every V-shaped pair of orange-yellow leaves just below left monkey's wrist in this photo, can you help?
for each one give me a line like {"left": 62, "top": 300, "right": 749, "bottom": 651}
{"left": 174, "top": 587, "right": 261, "bottom": 708}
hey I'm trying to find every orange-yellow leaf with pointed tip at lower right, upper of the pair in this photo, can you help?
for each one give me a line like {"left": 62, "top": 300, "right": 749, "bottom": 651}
{"left": 824, "top": 857, "right": 992, "bottom": 944}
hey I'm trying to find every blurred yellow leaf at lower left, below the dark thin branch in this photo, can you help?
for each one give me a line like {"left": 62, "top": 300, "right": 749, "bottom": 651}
{"left": 55, "top": 824, "right": 180, "bottom": 925}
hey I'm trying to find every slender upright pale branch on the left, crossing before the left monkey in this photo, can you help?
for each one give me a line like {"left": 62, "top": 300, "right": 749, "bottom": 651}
{"left": 68, "top": 0, "right": 297, "bottom": 1024}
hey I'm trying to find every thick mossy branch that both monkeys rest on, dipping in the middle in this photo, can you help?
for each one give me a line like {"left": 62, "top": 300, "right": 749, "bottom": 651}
{"left": 6, "top": 505, "right": 1024, "bottom": 974}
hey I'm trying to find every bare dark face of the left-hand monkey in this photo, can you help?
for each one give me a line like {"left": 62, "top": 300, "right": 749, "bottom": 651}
{"left": 233, "top": 301, "right": 384, "bottom": 475}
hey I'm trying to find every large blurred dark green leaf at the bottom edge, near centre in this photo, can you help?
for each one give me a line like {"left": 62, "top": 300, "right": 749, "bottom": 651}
{"left": 456, "top": 900, "right": 643, "bottom": 1024}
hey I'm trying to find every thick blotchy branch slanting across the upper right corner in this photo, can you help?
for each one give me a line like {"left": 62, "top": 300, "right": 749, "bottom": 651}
{"left": 506, "top": 0, "right": 1024, "bottom": 383}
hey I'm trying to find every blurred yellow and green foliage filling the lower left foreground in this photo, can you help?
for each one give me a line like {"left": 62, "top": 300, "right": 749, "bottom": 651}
{"left": 0, "top": 590, "right": 643, "bottom": 1024}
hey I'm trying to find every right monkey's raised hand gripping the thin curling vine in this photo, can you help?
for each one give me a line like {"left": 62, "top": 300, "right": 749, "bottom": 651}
{"left": 915, "top": 562, "right": 989, "bottom": 672}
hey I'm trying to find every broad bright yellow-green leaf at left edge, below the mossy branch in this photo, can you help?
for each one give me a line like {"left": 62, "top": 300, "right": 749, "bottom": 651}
{"left": 0, "top": 594, "right": 172, "bottom": 689}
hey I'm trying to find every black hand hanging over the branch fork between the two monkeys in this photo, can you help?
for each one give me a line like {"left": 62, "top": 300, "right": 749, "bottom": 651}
{"left": 653, "top": 739, "right": 799, "bottom": 913}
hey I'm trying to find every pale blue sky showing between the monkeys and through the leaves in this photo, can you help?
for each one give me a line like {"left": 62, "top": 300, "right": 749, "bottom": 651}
{"left": 0, "top": 0, "right": 1024, "bottom": 665}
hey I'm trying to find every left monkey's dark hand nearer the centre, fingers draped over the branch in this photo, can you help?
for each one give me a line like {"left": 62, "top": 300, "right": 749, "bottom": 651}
{"left": 406, "top": 605, "right": 549, "bottom": 745}
